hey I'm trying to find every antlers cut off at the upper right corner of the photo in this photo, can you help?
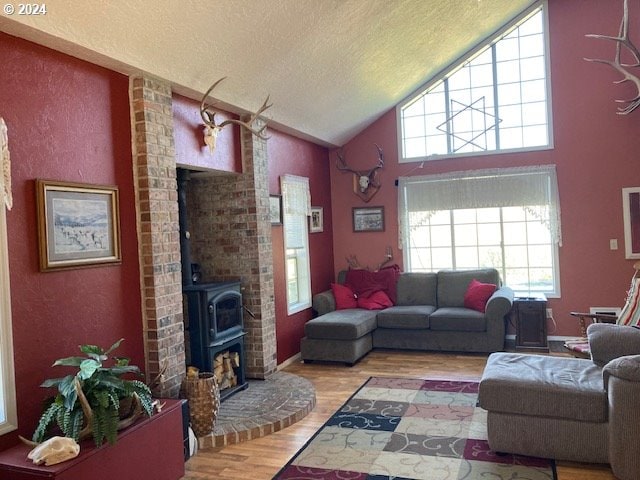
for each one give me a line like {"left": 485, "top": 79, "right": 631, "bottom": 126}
{"left": 585, "top": 0, "right": 640, "bottom": 115}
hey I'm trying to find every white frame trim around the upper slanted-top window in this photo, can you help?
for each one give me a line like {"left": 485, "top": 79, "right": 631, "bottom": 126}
{"left": 395, "top": 0, "right": 555, "bottom": 164}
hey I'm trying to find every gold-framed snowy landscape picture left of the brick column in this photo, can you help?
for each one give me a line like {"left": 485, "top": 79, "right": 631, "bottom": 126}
{"left": 36, "top": 179, "right": 122, "bottom": 272}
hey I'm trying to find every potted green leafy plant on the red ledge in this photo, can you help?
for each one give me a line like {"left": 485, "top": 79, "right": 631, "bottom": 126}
{"left": 33, "top": 339, "right": 153, "bottom": 446}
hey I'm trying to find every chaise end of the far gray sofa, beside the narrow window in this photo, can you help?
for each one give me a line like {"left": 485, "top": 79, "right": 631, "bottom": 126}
{"left": 300, "top": 309, "right": 377, "bottom": 365}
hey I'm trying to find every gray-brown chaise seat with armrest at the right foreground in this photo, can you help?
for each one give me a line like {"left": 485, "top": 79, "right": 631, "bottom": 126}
{"left": 478, "top": 324, "right": 640, "bottom": 480}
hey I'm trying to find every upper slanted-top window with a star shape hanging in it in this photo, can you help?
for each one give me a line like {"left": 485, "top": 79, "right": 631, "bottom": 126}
{"left": 398, "top": 0, "right": 552, "bottom": 162}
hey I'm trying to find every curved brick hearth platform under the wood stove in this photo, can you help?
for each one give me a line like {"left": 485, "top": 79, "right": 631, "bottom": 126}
{"left": 198, "top": 372, "right": 316, "bottom": 448}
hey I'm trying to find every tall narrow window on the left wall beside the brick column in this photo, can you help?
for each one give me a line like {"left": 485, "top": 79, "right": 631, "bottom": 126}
{"left": 280, "top": 175, "right": 311, "bottom": 314}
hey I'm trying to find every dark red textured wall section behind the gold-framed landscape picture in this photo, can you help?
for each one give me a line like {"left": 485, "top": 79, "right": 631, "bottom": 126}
{"left": 0, "top": 33, "right": 144, "bottom": 449}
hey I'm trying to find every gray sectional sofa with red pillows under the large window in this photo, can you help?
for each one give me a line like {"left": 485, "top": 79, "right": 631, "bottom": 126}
{"left": 300, "top": 268, "right": 513, "bottom": 364}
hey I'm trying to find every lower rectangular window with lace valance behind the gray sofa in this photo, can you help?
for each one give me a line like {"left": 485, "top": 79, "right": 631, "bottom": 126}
{"left": 399, "top": 166, "right": 561, "bottom": 296}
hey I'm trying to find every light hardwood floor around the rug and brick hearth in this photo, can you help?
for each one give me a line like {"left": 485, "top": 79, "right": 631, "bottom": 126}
{"left": 183, "top": 350, "right": 615, "bottom": 480}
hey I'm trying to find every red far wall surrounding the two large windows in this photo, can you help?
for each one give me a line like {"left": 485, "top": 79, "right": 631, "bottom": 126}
{"left": 331, "top": 0, "right": 640, "bottom": 335}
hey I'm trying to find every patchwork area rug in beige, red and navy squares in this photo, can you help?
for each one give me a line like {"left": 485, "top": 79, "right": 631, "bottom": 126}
{"left": 274, "top": 377, "right": 557, "bottom": 480}
